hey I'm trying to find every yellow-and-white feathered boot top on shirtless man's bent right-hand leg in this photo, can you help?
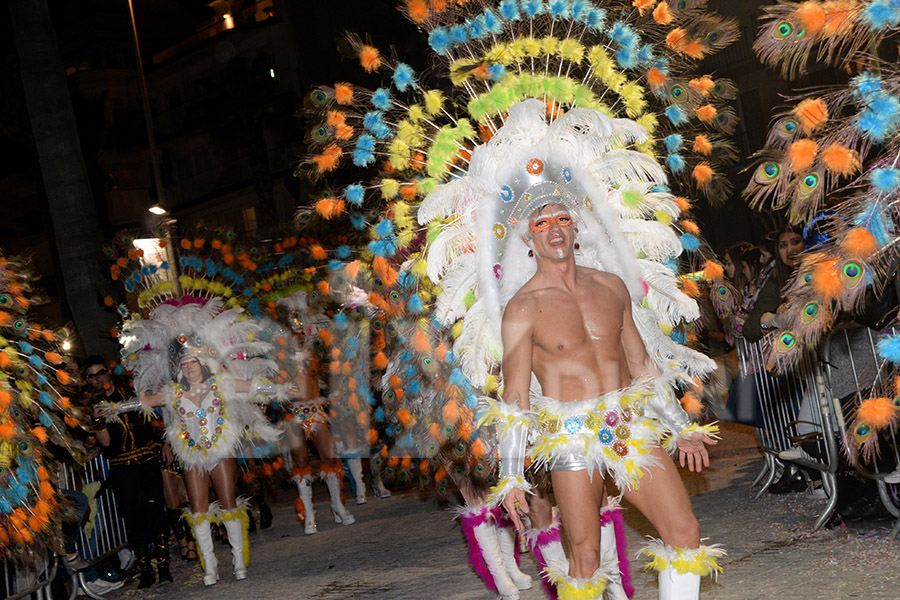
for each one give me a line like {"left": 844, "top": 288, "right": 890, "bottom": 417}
{"left": 640, "top": 538, "right": 725, "bottom": 600}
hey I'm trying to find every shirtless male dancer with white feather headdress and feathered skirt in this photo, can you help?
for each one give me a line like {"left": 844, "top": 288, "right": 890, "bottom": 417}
{"left": 420, "top": 101, "right": 722, "bottom": 599}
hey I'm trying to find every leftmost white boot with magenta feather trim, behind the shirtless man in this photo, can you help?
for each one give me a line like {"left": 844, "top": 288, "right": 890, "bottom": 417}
{"left": 457, "top": 504, "right": 519, "bottom": 600}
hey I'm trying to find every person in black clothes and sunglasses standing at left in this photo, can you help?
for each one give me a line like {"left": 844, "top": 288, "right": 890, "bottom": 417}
{"left": 82, "top": 355, "right": 172, "bottom": 588}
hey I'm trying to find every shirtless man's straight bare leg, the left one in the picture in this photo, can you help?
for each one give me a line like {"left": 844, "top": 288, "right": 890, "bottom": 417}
{"left": 550, "top": 471, "right": 606, "bottom": 577}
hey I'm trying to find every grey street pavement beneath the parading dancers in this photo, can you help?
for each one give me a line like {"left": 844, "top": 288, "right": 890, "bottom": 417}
{"left": 107, "top": 424, "right": 900, "bottom": 600}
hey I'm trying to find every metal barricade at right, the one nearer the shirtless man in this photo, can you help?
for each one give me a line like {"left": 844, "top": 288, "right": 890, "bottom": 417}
{"left": 735, "top": 337, "right": 838, "bottom": 529}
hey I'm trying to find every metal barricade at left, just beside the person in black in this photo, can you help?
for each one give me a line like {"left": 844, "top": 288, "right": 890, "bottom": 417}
{"left": 59, "top": 455, "right": 128, "bottom": 600}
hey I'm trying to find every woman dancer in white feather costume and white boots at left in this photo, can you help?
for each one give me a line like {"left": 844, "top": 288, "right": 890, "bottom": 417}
{"left": 104, "top": 298, "right": 296, "bottom": 585}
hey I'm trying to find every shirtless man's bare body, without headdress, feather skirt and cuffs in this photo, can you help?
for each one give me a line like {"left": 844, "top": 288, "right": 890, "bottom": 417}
{"left": 501, "top": 204, "right": 716, "bottom": 598}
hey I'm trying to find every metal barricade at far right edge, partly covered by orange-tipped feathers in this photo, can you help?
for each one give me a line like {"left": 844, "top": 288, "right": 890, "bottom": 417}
{"left": 821, "top": 324, "right": 900, "bottom": 538}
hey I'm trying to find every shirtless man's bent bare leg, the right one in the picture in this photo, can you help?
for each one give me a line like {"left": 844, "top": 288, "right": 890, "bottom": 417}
{"left": 624, "top": 448, "right": 700, "bottom": 548}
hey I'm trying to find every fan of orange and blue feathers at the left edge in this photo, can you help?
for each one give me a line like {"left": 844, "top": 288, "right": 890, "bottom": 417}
{"left": 0, "top": 254, "right": 83, "bottom": 562}
